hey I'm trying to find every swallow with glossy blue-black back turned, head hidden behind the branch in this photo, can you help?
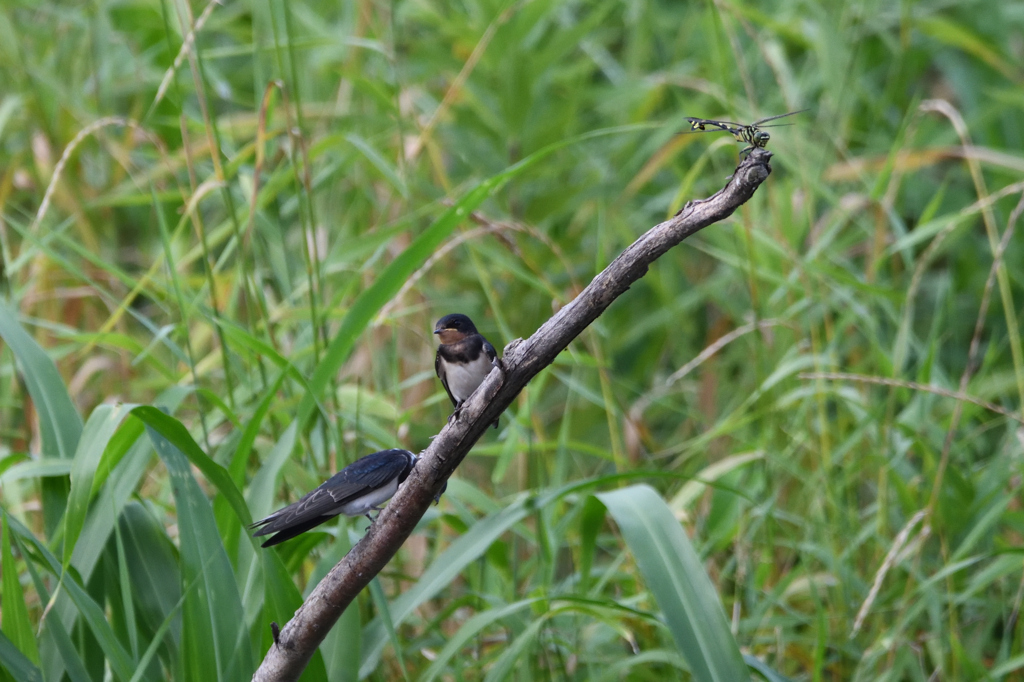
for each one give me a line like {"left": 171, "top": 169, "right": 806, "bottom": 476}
{"left": 249, "top": 449, "right": 447, "bottom": 547}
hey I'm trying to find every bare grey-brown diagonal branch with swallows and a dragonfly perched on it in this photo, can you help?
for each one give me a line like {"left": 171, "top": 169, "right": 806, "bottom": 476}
{"left": 253, "top": 148, "right": 772, "bottom": 682}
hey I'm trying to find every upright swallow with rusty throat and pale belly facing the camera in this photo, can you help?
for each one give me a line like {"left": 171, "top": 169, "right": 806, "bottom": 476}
{"left": 434, "top": 313, "right": 505, "bottom": 429}
